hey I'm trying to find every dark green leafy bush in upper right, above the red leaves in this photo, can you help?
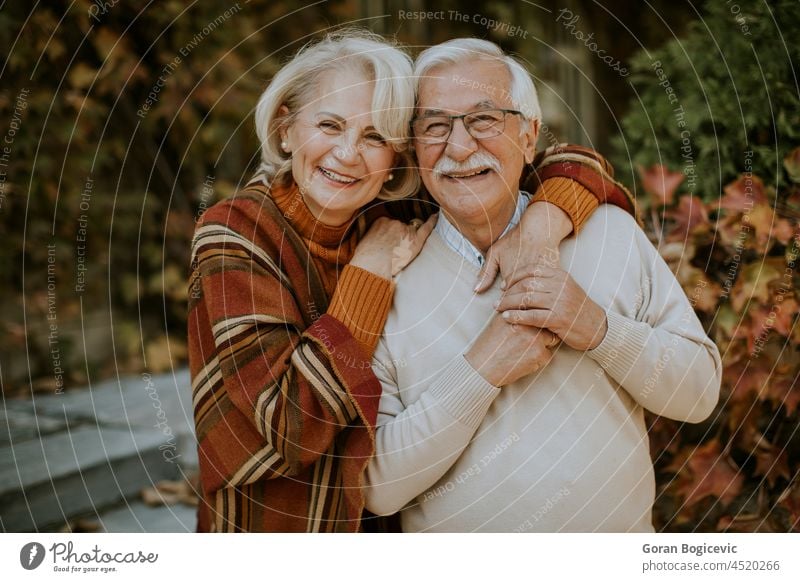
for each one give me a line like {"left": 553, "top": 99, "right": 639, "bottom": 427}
{"left": 613, "top": 0, "right": 800, "bottom": 208}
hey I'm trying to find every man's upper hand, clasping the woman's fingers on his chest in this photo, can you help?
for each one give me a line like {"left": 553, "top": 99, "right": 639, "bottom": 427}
{"left": 496, "top": 264, "right": 608, "bottom": 351}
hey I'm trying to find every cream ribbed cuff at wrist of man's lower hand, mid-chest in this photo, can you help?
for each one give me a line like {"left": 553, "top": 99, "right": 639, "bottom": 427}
{"left": 429, "top": 355, "right": 500, "bottom": 429}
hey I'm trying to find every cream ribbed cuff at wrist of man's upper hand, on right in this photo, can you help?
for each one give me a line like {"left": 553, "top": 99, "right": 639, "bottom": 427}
{"left": 586, "top": 311, "right": 651, "bottom": 382}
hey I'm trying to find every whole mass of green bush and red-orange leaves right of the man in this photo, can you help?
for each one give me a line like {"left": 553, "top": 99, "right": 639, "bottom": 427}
{"left": 613, "top": 0, "right": 800, "bottom": 532}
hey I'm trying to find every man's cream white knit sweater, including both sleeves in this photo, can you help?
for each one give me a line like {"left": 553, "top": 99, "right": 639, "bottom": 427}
{"left": 366, "top": 205, "right": 721, "bottom": 532}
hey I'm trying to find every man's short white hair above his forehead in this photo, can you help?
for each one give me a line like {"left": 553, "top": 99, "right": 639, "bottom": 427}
{"left": 414, "top": 38, "right": 542, "bottom": 120}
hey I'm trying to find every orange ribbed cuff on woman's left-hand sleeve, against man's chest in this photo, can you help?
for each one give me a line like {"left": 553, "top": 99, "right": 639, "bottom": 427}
{"left": 328, "top": 265, "right": 394, "bottom": 358}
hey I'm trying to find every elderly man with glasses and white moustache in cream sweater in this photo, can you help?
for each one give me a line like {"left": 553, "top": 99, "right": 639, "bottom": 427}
{"left": 366, "top": 39, "right": 721, "bottom": 532}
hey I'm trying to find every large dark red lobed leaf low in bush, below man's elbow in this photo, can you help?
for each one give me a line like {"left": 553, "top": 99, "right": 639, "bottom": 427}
{"left": 678, "top": 441, "right": 744, "bottom": 506}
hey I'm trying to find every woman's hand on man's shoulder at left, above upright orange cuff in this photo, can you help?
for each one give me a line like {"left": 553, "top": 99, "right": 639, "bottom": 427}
{"left": 350, "top": 214, "right": 438, "bottom": 279}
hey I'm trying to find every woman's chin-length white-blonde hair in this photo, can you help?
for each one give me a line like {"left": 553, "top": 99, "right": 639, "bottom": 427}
{"left": 255, "top": 28, "right": 419, "bottom": 200}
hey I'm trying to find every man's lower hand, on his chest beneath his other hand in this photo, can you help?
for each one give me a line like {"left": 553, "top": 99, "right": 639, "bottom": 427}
{"left": 465, "top": 316, "right": 558, "bottom": 388}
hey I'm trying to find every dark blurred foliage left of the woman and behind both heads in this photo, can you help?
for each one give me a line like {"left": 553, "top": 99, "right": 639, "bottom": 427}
{"left": 0, "top": 0, "right": 691, "bottom": 393}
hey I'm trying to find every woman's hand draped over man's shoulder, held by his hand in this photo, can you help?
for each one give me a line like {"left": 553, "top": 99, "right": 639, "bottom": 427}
{"left": 475, "top": 202, "right": 572, "bottom": 293}
